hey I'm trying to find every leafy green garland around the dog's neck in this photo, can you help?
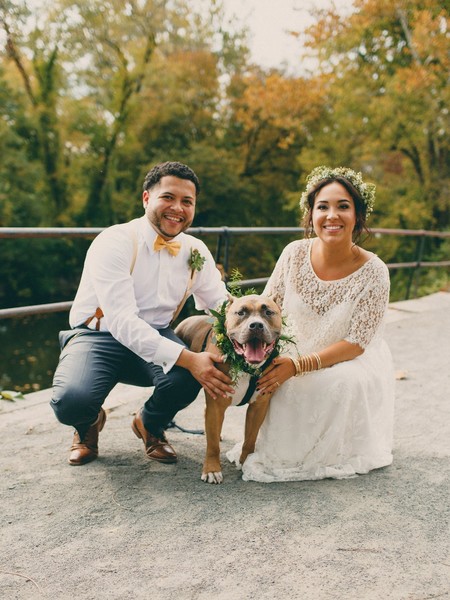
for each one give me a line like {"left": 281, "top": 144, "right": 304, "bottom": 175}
{"left": 210, "top": 269, "right": 295, "bottom": 383}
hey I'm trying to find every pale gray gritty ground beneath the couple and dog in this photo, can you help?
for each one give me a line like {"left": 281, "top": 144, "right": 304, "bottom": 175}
{"left": 0, "top": 292, "right": 450, "bottom": 600}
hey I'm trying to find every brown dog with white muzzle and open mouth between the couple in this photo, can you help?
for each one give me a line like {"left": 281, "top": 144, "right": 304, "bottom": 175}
{"left": 175, "top": 294, "right": 282, "bottom": 483}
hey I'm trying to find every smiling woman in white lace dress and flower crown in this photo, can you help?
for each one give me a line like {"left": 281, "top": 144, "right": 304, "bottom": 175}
{"left": 229, "top": 167, "right": 394, "bottom": 482}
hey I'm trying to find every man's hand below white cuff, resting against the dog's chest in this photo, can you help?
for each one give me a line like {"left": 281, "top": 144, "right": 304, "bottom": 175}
{"left": 175, "top": 348, "right": 234, "bottom": 398}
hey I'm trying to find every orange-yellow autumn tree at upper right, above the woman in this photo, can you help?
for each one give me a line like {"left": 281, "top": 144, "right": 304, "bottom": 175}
{"left": 301, "top": 0, "right": 450, "bottom": 229}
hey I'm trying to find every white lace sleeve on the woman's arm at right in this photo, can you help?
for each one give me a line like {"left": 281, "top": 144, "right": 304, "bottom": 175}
{"left": 345, "top": 260, "right": 390, "bottom": 348}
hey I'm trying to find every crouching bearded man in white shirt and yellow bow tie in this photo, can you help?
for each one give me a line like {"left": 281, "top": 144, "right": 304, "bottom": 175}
{"left": 51, "top": 162, "right": 233, "bottom": 465}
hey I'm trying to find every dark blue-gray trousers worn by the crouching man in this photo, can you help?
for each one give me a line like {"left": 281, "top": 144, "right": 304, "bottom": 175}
{"left": 50, "top": 327, "right": 201, "bottom": 439}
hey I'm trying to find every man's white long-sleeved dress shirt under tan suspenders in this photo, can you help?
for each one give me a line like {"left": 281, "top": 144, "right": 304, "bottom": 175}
{"left": 69, "top": 215, "right": 227, "bottom": 373}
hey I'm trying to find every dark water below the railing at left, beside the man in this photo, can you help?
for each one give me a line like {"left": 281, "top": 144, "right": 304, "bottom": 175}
{"left": 0, "top": 313, "right": 69, "bottom": 393}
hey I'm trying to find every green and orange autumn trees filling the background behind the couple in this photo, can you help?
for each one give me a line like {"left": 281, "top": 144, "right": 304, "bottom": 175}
{"left": 0, "top": 0, "right": 450, "bottom": 306}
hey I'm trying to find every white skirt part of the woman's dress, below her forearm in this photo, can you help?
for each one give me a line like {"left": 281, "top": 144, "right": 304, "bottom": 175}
{"left": 227, "top": 342, "right": 395, "bottom": 483}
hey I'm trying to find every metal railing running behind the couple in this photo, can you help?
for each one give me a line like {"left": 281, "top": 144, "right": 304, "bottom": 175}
{"left": 0, "top": 227, "right": 450, "bottom": 319}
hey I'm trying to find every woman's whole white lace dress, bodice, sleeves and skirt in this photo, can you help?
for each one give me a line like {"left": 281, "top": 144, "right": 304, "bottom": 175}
{"left": 228, "top": 240, "right": 394, "bottom": 482}
